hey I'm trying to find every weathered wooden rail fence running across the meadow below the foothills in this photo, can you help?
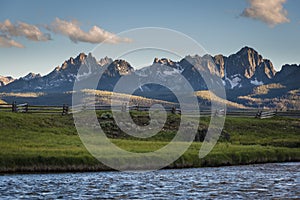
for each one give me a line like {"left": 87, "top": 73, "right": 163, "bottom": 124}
{"left": 0, "top": 102, "right": 300, "bottom": 119}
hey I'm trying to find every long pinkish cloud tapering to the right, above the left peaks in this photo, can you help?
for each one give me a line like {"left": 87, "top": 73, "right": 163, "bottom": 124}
{"left": 47, "top": 18, "right": 131, "bottom": 44}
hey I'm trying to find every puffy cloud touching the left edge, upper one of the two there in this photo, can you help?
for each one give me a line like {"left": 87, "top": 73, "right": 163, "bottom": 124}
{"left": 0, "top": 19, "right": 51, "bottom": 41}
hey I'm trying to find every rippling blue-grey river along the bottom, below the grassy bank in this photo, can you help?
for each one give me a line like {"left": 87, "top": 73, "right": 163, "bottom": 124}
{"left": 0, "top": 162, "right": 300, "bottom": 199}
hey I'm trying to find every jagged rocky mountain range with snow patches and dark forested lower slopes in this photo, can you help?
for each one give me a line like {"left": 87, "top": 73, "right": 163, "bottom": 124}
{"left": 0, "top": 46, "right": 300, "bottom": 109}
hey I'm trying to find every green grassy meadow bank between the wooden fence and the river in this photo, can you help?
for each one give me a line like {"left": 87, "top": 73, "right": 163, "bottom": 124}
{"left": 0, "top": 112, "right": 300, "bottom": 173}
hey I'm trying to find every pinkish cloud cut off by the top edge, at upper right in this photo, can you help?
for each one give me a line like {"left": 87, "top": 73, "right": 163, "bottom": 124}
{"left": 241, "top": 0, "right": 290, "bottom": 27}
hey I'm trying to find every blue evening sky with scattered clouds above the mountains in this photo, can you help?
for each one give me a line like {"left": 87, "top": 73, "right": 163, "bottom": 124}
{"left": 0, "top": 0, "right": 300, "bottom": 78}
